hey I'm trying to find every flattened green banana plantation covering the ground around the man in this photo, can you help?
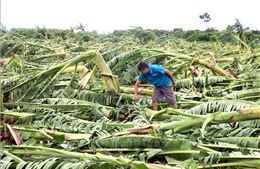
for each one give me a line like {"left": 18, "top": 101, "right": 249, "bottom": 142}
{"left": 0, "top": 28, "right": 260, "bottom": 169}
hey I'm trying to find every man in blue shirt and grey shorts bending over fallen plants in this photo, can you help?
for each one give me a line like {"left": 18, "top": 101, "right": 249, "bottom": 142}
{"left": 133, "top": 61, "right": 177, "bottom": 110}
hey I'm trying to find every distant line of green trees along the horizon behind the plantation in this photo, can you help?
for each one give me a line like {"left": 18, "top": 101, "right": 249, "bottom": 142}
{"left": 1, "top": 19, "right": 260, "bottom": 49}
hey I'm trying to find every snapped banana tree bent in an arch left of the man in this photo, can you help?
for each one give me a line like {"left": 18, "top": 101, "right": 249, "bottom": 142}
{"left": 2, "top": 51, "right": 119, "bottom": 101}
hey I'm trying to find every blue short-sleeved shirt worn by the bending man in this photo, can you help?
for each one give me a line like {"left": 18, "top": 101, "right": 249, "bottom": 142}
{"left": 138, "top": 65, "right": 171, "bottom": 88}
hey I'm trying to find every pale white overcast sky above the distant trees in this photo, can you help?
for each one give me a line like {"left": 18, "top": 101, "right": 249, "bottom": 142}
{"left": 0, "top": 0, "right": 260, "bottom": 33}
